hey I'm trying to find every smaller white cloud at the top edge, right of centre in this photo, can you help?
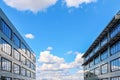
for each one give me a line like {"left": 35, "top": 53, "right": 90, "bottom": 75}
{"left": 64, "top": 0, "right": 96, "bottom": 8}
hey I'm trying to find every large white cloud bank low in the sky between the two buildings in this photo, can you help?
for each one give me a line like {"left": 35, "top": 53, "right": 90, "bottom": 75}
{"left": 37, "top": 48, "right": 83, "bottom": 80}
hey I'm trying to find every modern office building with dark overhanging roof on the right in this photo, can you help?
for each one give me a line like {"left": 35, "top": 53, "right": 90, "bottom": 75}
{"left": 82, "top": 12, "right": 120, "bottom": 80}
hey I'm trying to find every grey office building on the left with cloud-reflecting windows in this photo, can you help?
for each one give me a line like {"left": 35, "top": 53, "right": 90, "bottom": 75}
{"left": 0, "top": 9, "right": 36, "bottom": 80}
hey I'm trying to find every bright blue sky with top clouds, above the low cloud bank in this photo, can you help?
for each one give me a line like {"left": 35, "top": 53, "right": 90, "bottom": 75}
{"left": 0, "top": 0, "right": 120, "bottom": 80}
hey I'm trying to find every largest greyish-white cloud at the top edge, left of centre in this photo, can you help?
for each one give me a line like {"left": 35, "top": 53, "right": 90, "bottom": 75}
{"left": 3, "top": 0, "right": 57, "bottom": 13}
